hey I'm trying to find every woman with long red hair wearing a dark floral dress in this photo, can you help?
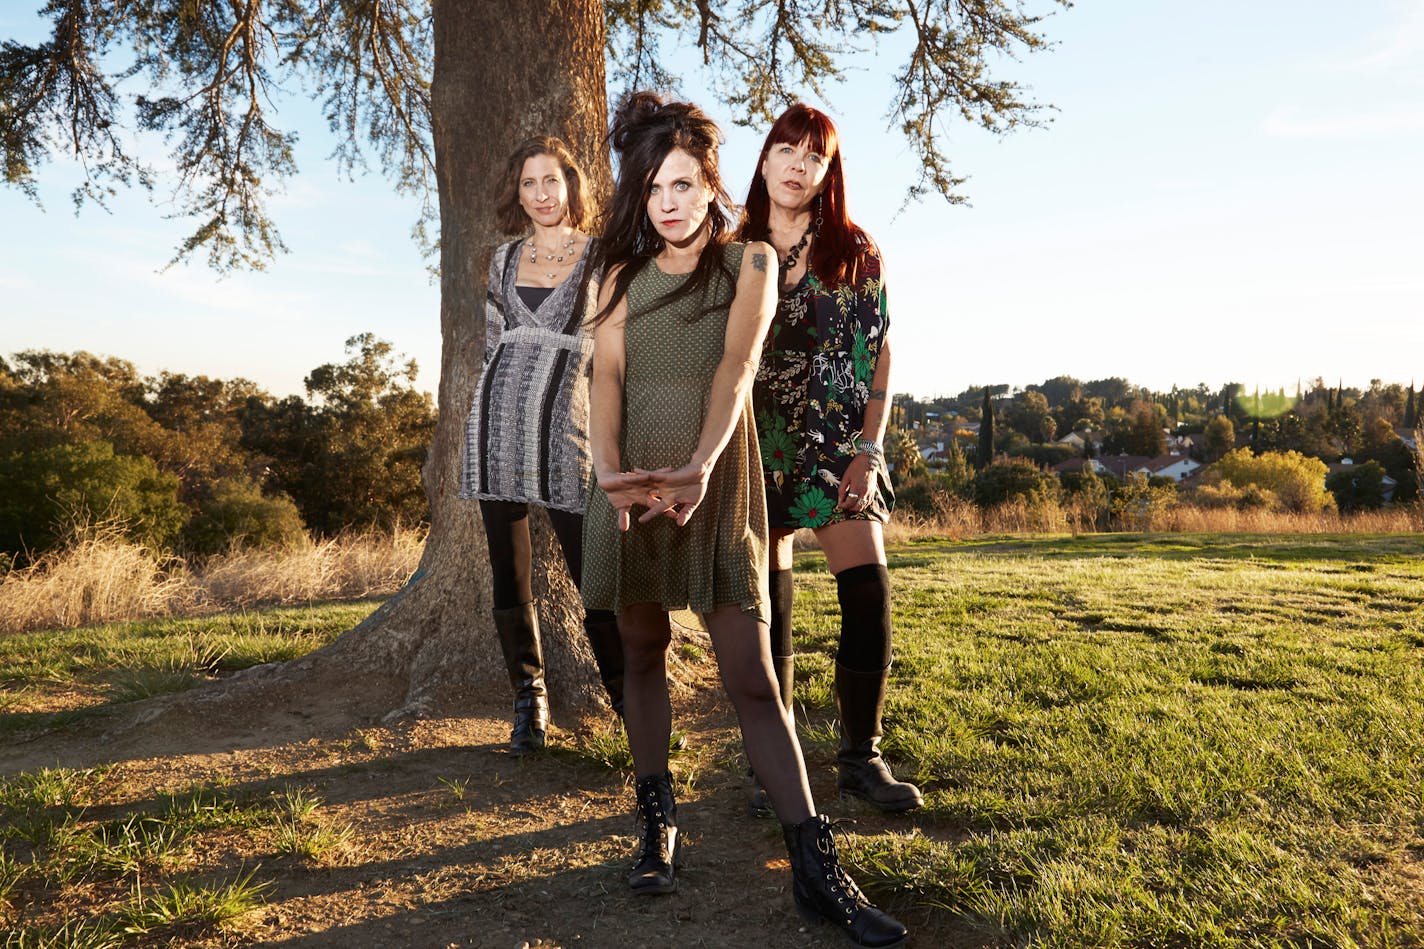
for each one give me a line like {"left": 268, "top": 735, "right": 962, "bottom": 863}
{"left": 738, "top": 104, "right": 923, "bottom": 815}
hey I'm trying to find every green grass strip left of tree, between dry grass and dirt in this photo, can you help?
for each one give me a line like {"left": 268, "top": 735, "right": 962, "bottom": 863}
{"left": 0, "top": 601, "right": 375, "bottom": 734}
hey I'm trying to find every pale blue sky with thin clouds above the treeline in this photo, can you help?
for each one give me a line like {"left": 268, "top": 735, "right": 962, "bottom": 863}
{"left": 0, "top": 0, "right": 1424, "bottom": 396}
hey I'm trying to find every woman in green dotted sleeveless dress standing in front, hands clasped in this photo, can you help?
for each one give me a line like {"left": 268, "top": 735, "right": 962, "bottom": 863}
{"left": 581, "top": 93, "right": 906, "bottom": 946}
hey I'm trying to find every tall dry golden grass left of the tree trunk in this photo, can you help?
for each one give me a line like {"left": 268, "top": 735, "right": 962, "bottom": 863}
{"left": 0, "top": 526, "right": 424, "bottom": 633}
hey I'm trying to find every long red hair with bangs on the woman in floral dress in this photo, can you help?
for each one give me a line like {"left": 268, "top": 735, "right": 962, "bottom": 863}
{"left": 738, "top": 103, "right": 874, "bottom": 288}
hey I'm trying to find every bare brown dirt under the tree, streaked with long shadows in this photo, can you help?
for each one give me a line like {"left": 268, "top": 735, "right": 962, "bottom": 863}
{"left": 0, "top": 661, "right": 974, "bottom": 949}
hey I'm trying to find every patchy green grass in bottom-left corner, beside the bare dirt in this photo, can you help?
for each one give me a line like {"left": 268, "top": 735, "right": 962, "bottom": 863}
{"left": 0, "top": 768, "right": 300, "bottom": 949}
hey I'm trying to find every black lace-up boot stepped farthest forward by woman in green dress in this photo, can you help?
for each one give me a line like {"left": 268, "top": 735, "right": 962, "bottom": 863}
{"left": 782, "top": 815, "right": 909, "bottom": 949}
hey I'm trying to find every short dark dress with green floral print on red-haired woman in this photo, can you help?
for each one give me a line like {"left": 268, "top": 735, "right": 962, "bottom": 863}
{"left": 752, "top": 240, "right": 894, "bottom": 529}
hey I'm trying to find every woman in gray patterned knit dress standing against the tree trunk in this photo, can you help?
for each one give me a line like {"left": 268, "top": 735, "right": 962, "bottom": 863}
{"left": 460, "top": 137, "right": 622, "bottom": 755}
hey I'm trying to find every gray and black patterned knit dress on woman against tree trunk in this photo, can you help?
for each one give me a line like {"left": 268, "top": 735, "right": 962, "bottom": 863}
{"left": 460, "top": 241, "right": 600, "bottom": 514}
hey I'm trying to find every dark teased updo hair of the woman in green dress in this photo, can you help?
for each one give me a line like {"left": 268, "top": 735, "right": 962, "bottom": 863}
{"left": 592, "top": 91, "right": 736, "bottom": 323}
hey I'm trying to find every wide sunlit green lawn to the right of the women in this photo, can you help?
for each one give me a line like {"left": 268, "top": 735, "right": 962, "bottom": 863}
{"left": 796, "top": 534, "right": 1424, "bottom": 946}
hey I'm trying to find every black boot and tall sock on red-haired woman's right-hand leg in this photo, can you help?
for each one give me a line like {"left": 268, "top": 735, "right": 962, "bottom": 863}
{"left": 836, "top": 564, "right": 924, "bottom": 812}
